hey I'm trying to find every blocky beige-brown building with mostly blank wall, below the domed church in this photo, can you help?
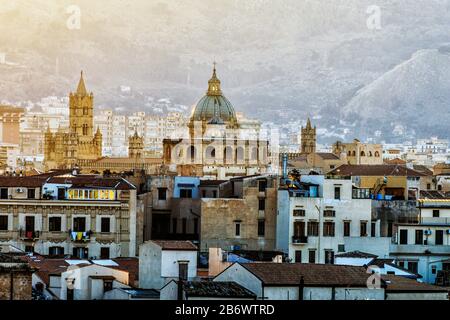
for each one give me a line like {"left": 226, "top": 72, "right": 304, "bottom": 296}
{"left": 200, "top": 175, "right": 278, "bottom": 251}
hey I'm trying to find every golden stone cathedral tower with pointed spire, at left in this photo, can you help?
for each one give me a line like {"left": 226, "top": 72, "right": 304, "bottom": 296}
{"left": 44, "top": 73, "right": 102, "bottom": 170}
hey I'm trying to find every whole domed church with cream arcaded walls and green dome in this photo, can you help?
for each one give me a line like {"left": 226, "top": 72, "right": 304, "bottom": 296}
{"left": 163, "top": 68, "right": 268, "bottom": 180}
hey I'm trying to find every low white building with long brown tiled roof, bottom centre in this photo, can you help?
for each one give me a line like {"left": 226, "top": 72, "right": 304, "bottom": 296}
{"left": 214, "top": 263, "right": 385, "bottom": 300}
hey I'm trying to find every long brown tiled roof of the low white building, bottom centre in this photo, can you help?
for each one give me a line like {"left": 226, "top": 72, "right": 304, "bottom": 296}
{"left": 241, "top": 263, "right": 376, "bottom": 287}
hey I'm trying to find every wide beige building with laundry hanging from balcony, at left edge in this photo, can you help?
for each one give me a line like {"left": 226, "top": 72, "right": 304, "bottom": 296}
{"left": 0, "top": 172, "right": 141, "bottom": 258}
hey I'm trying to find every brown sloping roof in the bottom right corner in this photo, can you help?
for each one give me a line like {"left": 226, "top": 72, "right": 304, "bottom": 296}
{"left": 381, "top": 274, "right": 448, "bottom": 293}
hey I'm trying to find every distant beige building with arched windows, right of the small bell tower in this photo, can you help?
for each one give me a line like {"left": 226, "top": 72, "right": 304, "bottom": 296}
{"left": 333, "top": 139, "right": 383, "bottom": 165}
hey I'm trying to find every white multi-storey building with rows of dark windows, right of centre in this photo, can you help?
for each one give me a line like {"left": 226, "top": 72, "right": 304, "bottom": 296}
{"left": 276, "top": 175, "right": 380, "bottom": 264}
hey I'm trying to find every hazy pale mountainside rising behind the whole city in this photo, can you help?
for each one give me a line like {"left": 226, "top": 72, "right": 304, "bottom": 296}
{"left": 0, "top": 0, "right": 450, "bottom": 140}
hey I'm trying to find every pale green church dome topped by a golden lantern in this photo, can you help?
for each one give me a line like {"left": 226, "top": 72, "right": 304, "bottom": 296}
{"left": 191, "top": 66, "right": 237, "bottom": 123}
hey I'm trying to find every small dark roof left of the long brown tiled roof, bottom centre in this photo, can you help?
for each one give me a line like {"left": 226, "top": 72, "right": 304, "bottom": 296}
{"left": 180, "top": 281, "right": 256, "bottom": 298}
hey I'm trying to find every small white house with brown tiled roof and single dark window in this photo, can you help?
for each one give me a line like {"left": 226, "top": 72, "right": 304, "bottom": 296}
{"left": 139, "top": 240, "right": 198, "bottom": 289}
